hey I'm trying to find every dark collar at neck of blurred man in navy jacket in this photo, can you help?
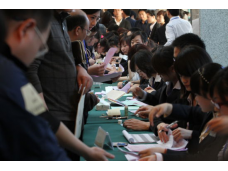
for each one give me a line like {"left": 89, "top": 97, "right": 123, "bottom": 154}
{"left": 1, "top": 43, "right": 28, "bottom": 72}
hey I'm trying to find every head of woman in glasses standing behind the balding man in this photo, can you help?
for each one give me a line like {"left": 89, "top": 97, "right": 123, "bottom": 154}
{"left": 82, "top": 9, "right": 101, "bottom": 30}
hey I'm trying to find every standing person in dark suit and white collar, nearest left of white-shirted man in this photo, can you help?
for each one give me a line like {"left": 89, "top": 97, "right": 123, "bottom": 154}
{"left": 146, "top": 10, "right": 160, "bottom": 40}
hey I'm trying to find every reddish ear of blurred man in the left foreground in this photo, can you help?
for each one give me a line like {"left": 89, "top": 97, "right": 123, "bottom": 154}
{"left": 16, "top": 18, "right": 36, "bottom": 42}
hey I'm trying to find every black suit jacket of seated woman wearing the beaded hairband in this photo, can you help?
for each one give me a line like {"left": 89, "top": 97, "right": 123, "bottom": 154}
{"left": 163, "top": 105, "right": 227, "bottom": 161}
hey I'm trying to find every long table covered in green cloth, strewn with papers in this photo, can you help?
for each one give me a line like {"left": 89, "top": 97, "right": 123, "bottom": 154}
{"left": 81, "top": 83, "right": 152, "bottom": 161}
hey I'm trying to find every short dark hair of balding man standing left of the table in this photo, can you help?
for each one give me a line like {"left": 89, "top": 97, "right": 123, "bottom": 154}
{"left": 66, "top": 15, "right": 87, "bottom": 31}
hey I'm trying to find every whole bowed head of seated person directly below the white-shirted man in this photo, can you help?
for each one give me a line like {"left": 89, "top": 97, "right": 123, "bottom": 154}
{"left": 151, "top": 46, "right": 177, "bottom": 82}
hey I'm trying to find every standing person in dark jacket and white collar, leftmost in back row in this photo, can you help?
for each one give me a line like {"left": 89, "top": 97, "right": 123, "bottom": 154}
{"left": 110, "top": 9, "right": 131, "bottom": 30}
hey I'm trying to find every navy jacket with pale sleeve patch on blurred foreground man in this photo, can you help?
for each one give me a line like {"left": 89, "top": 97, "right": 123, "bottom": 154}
{"left": 0, "top": 45, "right": 69, "bottom": 160}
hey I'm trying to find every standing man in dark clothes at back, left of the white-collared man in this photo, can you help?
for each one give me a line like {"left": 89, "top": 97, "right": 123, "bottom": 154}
{"left": 135, "top": 9, "right": 149, "bottom": 37}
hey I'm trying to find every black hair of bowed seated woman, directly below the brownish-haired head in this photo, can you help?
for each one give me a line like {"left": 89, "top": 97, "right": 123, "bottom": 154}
{"left": 131, "top": 49, "right": 156, "bottom": 78}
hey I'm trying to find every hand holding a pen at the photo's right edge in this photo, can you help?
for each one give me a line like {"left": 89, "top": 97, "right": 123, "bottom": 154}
{"left": 207, "top": 116, "right": 228, "bottom": 135}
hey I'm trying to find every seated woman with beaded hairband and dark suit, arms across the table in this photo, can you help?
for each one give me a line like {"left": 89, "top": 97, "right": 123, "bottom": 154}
{"left": 140, "top": 63, "right": 227, "bottom": 161}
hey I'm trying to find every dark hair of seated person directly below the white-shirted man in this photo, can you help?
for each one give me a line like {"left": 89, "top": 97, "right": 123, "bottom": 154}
{"left": 151, "top": 46, "right": 174, "bottom": 74}
